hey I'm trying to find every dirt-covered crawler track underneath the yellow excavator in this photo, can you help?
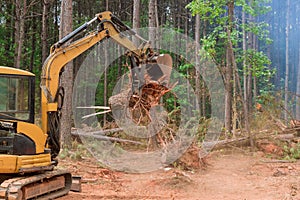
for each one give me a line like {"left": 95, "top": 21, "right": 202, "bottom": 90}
{"left": 0, "top": 170, "right": 72, "bottom": 200}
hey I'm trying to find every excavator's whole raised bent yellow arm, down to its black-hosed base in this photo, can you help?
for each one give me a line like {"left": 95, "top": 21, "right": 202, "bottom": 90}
{"left": 41, "top": 11, "right": 165, "bottom": 157}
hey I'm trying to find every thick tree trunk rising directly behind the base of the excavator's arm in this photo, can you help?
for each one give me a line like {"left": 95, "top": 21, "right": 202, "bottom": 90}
{"left": 59, "top": 0, "right": 73, "bottom": 147}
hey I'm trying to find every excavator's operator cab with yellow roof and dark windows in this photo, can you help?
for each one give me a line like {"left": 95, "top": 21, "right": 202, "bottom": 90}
{"left": 0, "top": 67, "right": 36, "bottom": 157}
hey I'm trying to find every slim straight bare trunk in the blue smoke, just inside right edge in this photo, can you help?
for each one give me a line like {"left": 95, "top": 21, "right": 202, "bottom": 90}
{"left": 284, "top": 0, "right": 290, "bottom": 123}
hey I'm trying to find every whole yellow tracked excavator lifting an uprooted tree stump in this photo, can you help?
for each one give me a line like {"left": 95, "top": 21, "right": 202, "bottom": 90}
{"left": 0, "top": 11, "right": 172, "bottom": 200}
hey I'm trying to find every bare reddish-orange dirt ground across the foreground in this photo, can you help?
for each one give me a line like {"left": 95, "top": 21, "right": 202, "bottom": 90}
{"left": 60, "top": 149, "right": 300, "bottom": 200}
